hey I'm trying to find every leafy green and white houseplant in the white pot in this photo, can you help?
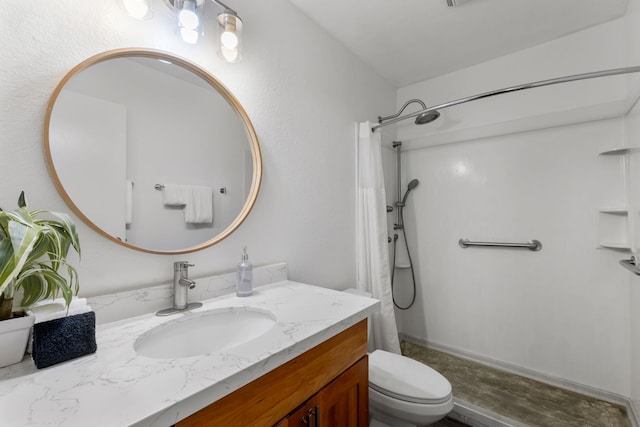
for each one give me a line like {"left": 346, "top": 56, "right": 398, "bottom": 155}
{"left": 0, "top": 191, "right": 80, "bottom": 321}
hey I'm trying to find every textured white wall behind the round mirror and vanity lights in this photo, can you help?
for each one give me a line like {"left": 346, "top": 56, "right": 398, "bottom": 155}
{"left": 0, "top": 0, "right": 395, "bottom": 295}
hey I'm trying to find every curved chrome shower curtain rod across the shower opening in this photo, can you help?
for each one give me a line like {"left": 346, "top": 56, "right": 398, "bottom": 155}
{"left": 371, "top": 66, "right": 640, "bottom": 132}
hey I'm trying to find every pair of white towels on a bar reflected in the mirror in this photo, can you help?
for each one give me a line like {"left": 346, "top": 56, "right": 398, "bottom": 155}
{"left": 162, "top": 184, "right": 213, "bottom": 224}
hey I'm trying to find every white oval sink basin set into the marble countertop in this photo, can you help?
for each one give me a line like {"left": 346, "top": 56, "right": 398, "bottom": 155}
{"left": 133, "top": 307, "right": 276, "bottom": 359}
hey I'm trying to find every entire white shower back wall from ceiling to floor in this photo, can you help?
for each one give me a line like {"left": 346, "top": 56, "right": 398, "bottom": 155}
{"left": 387, "top": 0, "right": 640, "bottom": 402}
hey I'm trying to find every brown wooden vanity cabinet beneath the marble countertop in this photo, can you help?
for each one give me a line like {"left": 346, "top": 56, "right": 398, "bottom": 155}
{"left": 176, "top": 320, "right": 369, "bottom": 427}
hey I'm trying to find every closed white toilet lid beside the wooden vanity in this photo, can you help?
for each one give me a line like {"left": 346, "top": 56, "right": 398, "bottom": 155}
{"left": 369, "top": 350, "right": 451, "bottom": 404}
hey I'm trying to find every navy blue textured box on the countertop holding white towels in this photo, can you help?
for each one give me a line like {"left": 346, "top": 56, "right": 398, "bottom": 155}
{"left": 31, "top": 311, "right": 98, "bottom": 369}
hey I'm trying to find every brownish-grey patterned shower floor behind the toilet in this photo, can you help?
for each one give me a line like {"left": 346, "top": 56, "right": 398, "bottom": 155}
{"left": 401, "top": 341, "right": 631, "bottom": 427}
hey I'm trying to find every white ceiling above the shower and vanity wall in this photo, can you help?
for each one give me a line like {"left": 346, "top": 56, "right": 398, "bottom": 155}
{"left": 289, "top": 0, "right": 629, "bottom": 87}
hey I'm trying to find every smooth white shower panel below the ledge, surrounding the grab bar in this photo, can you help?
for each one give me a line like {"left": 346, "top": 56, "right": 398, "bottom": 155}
{"left": 396, "top": 119, "right": 631, "bottom": 396}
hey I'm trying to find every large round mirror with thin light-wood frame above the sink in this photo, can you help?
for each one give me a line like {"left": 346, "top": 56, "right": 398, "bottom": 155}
{"left": 44, "top": 49, "right": 262, "bottom": 254}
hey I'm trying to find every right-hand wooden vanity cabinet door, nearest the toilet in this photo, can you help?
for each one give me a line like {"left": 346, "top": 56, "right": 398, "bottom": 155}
{"left": 318, "top": 357, "right": 369, "bottom": 427}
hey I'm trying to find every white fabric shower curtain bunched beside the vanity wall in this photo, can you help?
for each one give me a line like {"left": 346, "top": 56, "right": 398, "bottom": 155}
{"left": 356, "top": 122, "right": 400, "bottom": 354}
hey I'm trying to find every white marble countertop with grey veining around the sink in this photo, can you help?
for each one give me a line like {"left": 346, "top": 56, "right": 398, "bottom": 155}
{"left": 0, "top": 281, "right": 378, "bottom": 427}
